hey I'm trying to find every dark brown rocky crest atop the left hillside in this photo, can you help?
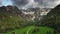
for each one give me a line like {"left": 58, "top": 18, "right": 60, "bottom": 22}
{"left": 0, "top": 5, "right": 22, "bottom": 16}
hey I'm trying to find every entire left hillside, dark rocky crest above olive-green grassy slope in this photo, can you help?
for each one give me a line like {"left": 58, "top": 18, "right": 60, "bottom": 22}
{"left": 0, "top": 6, "right": 27, "bottom": 34}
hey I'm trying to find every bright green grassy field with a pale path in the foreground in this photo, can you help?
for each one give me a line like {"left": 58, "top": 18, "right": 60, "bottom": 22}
{"left": 6, "top": 26, "right": 54, "bottom": 34}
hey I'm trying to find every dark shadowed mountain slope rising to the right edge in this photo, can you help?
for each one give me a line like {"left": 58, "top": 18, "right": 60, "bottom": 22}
{"left": 41, "top": 4, "right": 60, "bottom": 32}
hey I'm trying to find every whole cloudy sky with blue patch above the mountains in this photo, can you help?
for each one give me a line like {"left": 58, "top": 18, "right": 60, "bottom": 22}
{"left": 0, "top": 0, "right": 60, "bottom": 9}
